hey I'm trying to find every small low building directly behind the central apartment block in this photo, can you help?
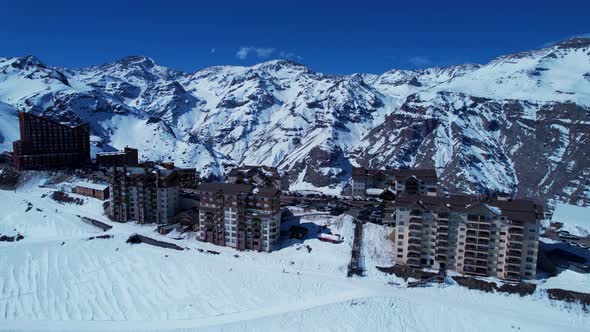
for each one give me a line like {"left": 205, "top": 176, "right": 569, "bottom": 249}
{"left": 227, "top": 166, "right": 289, "bottom": 191}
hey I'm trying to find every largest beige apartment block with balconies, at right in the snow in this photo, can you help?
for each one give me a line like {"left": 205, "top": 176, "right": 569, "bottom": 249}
{"left": 391, "top": 195, "right": 543, "bottom": 280}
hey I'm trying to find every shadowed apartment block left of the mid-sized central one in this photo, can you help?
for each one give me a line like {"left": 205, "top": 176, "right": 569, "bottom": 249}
{"left": 108, "top": 167, "right": 179, "bottom": 224}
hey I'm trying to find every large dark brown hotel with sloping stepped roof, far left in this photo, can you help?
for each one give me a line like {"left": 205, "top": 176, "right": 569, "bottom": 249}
{"left": 13, "top": 112, "right": 90, "bottom": 169}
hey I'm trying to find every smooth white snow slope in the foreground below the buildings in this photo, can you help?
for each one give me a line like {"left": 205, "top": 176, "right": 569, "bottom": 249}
{"left": 0, "top": 181, "right": 590, "bottom": 332}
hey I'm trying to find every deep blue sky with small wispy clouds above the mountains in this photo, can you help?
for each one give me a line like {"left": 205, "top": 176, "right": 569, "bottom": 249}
{"left": 0, "top": 0, "right": 590, "bottom": 74}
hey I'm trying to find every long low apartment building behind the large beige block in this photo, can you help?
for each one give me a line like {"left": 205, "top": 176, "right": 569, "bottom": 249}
{"left": 352, "top": 167, "right": 441, "bottom": 196}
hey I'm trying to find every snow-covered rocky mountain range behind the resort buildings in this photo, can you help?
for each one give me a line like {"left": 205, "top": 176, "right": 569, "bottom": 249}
{"left": 0, "top": 38, "right": 590, "bottom": 205}
